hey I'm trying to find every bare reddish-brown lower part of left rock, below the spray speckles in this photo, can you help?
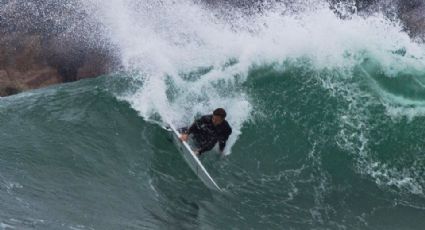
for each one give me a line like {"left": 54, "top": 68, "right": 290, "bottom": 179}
{"left": 0, "top": 33, "right": 118, "bottom": 96}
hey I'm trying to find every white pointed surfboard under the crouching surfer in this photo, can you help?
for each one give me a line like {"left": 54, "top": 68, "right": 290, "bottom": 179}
{"left": 168, "top": 124, "right": 222, "bottom": 192}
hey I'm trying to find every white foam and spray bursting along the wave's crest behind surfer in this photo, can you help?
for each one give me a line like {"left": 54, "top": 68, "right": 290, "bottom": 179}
{"left": 83, "top": 0, "right": 425, "bottom": 190}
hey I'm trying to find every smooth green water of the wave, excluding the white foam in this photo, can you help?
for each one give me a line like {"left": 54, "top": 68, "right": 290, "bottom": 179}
{"left": 0, "top": 56, "right": 425, "bottom": 229}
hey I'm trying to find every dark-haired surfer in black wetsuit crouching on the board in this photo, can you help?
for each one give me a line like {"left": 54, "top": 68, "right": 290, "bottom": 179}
{"left": 180, "top": 108, "right": 232, "bottom": 155}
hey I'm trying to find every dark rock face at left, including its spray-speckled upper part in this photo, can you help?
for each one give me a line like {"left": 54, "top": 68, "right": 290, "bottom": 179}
{"left": 0, "top": 0, "right": 119, "bottom": 96}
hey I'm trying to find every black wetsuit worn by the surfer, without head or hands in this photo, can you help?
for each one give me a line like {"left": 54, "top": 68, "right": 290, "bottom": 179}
{"left": 186, "top": 115, "right": 232, "bottom": 154}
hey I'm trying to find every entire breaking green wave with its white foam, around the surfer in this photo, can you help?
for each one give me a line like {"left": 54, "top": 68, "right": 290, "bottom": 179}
{"left": 0, "top": 0, "right": 425, "bottom": 229}
